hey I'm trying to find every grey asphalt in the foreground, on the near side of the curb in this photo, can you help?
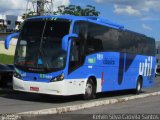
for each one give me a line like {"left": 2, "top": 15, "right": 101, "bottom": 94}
{"left": 21, "top": 96, "right": 160, "bottom": 120}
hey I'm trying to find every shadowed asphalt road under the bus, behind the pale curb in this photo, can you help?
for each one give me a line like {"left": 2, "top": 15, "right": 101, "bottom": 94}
{"left": 0, "top": 77, "right": 160, "bottom": 114}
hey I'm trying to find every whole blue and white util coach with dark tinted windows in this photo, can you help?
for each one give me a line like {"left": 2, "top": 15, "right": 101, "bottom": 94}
{"left": 5, "top": 15, "right": 156, "bottom": 99}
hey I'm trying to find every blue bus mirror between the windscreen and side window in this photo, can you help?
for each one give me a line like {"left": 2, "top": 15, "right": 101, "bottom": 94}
{"left": 62, "top": 34, "right": 78, "bottom": 51}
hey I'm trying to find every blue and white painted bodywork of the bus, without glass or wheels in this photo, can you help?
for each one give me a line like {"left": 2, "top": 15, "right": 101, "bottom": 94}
{"left": 5, "top": 16, "right": 156, "bottom": 98}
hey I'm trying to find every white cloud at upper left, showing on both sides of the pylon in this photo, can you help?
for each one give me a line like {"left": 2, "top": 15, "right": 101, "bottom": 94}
{"left": 0, "top": 0, "right": 70, "bottom": 15}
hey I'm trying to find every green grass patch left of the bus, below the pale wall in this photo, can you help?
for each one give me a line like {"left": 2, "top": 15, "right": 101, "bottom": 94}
{"left": 0, "top": 54, "right": 14, "bottom": 64}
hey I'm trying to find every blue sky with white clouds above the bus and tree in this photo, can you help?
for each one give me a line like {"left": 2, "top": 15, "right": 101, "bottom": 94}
{"left": 0, "top": 0, "right": 160, "bottom": 41}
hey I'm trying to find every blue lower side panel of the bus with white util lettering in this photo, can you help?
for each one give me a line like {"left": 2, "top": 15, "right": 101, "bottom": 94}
{"left": 68, "top": 52, "right": 155, "bottom": 92}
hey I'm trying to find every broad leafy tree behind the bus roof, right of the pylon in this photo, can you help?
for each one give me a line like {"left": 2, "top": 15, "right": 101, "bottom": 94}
{"left": 54, "top": 5, "right": 100, "bottom": 16}
